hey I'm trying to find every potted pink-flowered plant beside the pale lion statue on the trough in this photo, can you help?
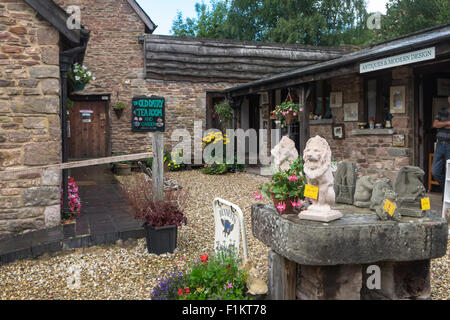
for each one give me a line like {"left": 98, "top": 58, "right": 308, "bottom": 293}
{"left": 261, "top": 157, "right": 306, "bottom": 201}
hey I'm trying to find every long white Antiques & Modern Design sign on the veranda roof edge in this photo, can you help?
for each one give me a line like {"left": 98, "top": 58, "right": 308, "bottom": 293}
{"left": 360, "top": 47, "right": 436, "bottom": 73}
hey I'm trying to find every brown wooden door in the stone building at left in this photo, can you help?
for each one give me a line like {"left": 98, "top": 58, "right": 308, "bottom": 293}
{"left": 68, "top": 101, "right": 108, "bottom": 159}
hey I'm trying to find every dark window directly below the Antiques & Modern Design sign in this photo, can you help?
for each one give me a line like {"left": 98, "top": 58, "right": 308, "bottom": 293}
{"left": 364, "top": 73, "right": 392, "bottom": 124}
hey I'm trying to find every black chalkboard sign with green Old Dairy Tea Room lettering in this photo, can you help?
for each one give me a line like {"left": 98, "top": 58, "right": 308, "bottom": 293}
{"left": 131, "top": 96, "right": 166, "bottom": 132}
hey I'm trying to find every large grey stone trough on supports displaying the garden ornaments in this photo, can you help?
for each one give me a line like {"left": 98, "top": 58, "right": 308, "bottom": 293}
{"left": 252, "top": 204, "right": 448, "bottom": 300}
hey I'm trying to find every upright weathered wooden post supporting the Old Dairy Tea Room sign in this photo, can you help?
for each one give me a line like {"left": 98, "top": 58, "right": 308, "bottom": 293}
{"left": 152, "top": 132, "right": 164, "bottom": 201}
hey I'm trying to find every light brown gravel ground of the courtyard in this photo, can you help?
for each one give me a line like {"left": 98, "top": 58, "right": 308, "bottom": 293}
{"left": 0, "top": 171, "right": 450, "bottom": 300}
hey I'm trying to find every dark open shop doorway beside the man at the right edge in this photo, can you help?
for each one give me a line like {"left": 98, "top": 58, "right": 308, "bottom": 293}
{"left": 415, "top": 61, "right": 450, "bottom": 191}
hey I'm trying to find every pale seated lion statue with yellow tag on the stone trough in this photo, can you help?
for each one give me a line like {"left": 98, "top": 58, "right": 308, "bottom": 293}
{"left": 299, "top": 136, "right": 343, "bottom": 222}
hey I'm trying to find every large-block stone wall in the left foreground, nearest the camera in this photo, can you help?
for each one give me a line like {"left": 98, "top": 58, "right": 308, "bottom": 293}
{"left": 0, "top": 0, "right": 61, "bottom": 238}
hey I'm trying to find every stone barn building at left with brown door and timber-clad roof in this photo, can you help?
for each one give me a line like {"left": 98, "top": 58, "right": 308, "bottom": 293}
{"left": 0, "top": 0, "right": 344, "bottom": 238}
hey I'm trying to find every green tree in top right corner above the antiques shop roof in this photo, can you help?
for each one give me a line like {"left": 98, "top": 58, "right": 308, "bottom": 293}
{"left": 373, "top": 0, "right": 450, "bottom": 41}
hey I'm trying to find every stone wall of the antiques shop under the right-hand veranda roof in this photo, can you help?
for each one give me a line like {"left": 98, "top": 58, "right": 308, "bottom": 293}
{"left": 311, "top": 67, "right": 413, "bottom": 179}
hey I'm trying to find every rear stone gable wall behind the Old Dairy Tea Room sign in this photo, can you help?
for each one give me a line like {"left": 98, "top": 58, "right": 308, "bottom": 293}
{"left": 56, "top": 0, "right": 231, "bottom": 155}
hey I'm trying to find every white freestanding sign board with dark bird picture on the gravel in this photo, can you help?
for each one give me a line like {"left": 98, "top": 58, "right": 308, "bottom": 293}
{"left": 213, "top": 198, "right": 248, "bottom": 259}
